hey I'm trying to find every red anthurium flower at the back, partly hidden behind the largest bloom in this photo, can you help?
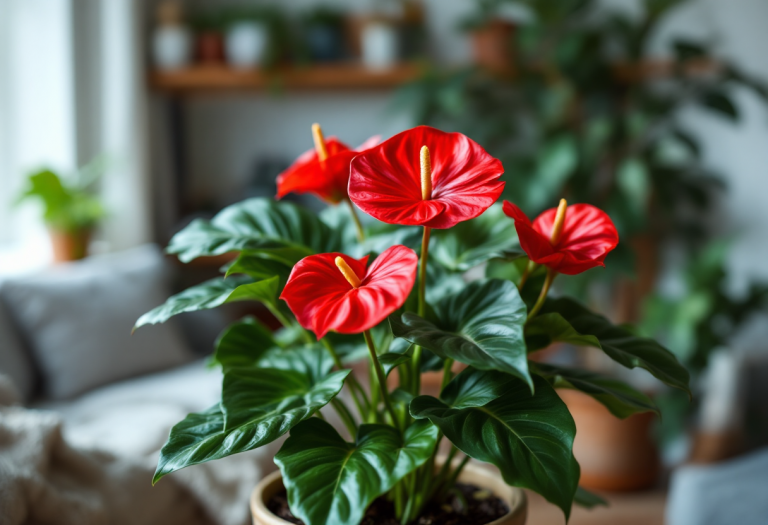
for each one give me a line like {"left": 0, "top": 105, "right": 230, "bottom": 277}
{"left": 277, "top": 124, "right": 379, "bottom": 204}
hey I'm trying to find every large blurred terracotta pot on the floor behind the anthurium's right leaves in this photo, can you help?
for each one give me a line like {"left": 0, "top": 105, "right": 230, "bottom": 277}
{"left": 558, "top": 390, "right": 660, "bottom": 491}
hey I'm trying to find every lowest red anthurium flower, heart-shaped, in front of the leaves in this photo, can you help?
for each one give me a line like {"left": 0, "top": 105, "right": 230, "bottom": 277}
{"left": 280, "top": 245, "right": 418, "bottom": 339}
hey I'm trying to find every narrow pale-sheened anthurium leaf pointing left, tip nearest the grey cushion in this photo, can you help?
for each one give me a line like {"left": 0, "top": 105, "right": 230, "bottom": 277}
{"left": 134, "top": 275, "right": 279, "bottom": 330}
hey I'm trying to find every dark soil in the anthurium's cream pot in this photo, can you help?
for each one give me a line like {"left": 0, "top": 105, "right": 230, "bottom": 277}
{"left": 267, "top": 483, "right": 509, "bottom": 525}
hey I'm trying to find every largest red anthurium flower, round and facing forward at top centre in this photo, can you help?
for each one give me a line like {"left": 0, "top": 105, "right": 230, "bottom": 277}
{"left": 349, "top": 126, "right": 504, "bottom": 228}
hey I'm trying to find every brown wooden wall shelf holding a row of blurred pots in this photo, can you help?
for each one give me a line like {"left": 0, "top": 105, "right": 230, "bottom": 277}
{"left": 150, "top": 64, "right": 420, "bottom": 93}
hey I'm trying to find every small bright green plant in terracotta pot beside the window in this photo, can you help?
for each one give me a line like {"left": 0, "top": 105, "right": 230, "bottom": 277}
{"left": 19, "top": 160, "right": 105, "bottom": 262}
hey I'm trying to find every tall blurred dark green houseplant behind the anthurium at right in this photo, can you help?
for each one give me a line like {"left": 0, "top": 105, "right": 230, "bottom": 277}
{"left": 398, "top": 0, "right": 768, "bottom": 454}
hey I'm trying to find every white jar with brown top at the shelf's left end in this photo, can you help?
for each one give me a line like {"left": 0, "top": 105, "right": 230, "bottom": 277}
{"left": 152, "top": 0, "right": 192, "bottom": 71}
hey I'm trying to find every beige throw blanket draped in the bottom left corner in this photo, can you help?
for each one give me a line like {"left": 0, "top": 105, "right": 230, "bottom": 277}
{"left": 0, "top": 376, "right": 212, "bottom": 525}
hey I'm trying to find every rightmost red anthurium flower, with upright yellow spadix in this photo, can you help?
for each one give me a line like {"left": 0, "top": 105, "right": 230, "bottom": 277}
{"left": 504, "top": 200, "right": 619, "bottom": 275}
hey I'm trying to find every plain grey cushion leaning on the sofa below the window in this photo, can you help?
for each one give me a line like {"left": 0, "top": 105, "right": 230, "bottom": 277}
{"left": 0, "top": 246, "right": 190, "bottom": 399}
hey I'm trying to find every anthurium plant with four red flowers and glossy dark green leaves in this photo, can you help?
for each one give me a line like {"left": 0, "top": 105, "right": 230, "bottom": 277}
{"left": 137, "top": 125, "right": 688, "bottom": 525}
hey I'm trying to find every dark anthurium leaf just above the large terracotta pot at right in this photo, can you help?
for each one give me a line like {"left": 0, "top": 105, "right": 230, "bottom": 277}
{"left": 534, "top": 363, "right": 659, "bottom": 419}
